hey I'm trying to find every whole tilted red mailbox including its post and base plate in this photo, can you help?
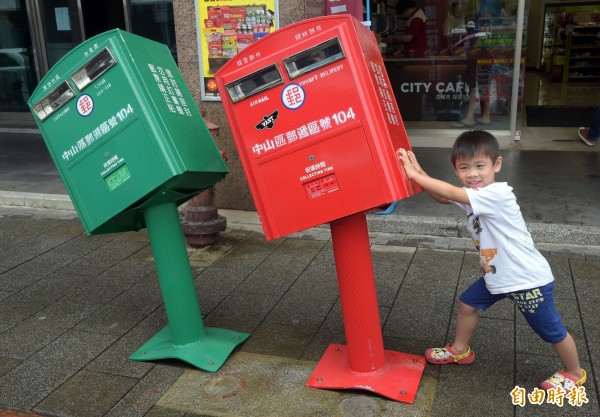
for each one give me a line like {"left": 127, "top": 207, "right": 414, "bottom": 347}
{"left": 215, "top": 15, "right": 425, "bottom": 402}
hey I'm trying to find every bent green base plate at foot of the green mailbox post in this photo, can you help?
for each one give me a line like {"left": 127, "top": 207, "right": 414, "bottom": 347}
{"left": 129, "top": 325, "right": 250, "bottom": 372}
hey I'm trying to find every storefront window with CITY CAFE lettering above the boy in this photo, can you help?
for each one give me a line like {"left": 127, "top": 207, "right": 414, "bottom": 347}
{"left": 376, "top": 0, "right": 527, "bottom": 130}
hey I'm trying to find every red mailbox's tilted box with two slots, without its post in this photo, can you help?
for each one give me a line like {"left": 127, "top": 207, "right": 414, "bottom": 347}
{"left": 215, "top": 15, "right": 422, "bottom": 240}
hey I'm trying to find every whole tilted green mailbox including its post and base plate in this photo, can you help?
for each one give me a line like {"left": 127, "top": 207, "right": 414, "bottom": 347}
{"left": 28, "top": 29, "right": 249, "bottom": 372}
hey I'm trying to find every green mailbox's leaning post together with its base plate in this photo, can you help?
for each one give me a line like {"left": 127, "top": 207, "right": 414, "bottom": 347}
{"left": 129, "top": 202, "right": 250, "bottom": 372}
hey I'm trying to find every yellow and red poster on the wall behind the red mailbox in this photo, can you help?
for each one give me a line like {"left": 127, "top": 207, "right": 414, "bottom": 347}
{"left": 196, "top": 0, "right": 279, "bottom": 101}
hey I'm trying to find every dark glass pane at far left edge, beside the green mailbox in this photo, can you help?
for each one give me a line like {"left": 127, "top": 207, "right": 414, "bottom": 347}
{"left": 0, "top": 0, "right": 35, "bottom": 112}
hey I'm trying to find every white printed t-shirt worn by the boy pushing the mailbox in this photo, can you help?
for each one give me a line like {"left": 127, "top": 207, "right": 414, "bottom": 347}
{"left": 452, "top": 182, "right": 554, "bottom": 294}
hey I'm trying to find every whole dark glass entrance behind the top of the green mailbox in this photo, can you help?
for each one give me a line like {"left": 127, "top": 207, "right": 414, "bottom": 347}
{"left": 0, "top": 0, "right": 177, "bottom": 125}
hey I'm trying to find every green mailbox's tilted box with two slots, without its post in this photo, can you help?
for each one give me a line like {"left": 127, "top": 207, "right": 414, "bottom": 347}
{"left": 29, "top": 29, "right": 228, "bottom": 234}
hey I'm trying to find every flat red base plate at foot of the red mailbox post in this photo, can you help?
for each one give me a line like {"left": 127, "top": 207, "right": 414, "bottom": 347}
{"left": 306, "top": 344, "right": 426, "bottom": 404}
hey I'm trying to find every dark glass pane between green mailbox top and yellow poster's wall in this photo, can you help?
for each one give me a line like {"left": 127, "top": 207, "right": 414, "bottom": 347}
{"left": 129, "top": 0, "right": 177, "bottom": 61}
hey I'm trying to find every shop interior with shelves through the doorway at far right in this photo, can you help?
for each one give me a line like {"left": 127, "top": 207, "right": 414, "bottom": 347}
{"left": 515, "top": 2, "right": 600, "bottom": 152}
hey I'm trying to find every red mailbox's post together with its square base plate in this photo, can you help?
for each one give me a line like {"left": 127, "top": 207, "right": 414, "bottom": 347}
{"left": 306, "top": 213, "right": 425, "bottom": 403}
